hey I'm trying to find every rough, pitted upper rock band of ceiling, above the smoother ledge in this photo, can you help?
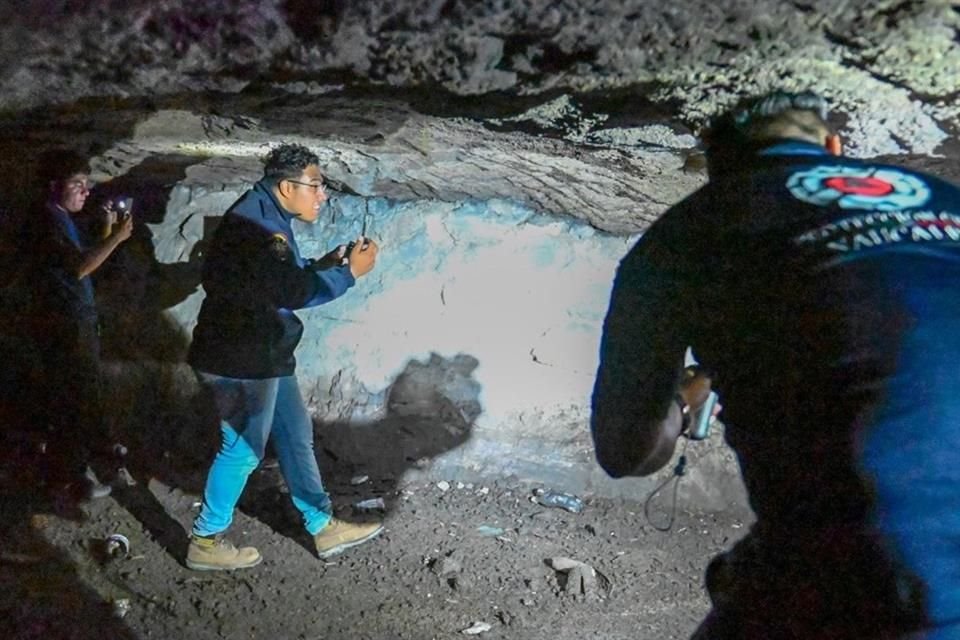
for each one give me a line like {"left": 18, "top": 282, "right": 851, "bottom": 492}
{"left": 0, "top": 0, "right": 960, "bottom": 155}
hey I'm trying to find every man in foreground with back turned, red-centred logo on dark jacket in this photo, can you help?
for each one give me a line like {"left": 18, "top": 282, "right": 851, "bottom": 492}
{"left": 592, "top": 92, "right": 960, "bottom": 640}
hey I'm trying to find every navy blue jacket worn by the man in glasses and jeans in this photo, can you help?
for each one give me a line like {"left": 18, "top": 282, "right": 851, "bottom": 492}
{"left": 187, "top": 182, "right": 355, "bottom": 378}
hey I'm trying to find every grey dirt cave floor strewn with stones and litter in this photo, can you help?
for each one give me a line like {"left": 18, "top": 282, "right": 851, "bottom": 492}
{"left": 0, "top": 428, "right": 748, "bottom": 640}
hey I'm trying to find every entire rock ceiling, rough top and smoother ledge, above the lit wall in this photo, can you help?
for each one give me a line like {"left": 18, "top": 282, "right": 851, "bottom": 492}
{"left": 0, "top": 0, "right": 960, "bottom": 232}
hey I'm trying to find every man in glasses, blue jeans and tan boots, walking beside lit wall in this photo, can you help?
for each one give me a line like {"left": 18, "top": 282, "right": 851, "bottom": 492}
{"left": 186, "top": 144, "right": 382, "bottom": 570}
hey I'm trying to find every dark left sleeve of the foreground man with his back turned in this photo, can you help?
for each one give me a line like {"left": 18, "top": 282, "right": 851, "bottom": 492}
{"left": 590, "top": 214, "right": 688, "bottom": 477}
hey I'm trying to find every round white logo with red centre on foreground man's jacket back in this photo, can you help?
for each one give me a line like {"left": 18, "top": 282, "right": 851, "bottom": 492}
{"left": 787, "top": 166, "right": 931, "bottom": 211}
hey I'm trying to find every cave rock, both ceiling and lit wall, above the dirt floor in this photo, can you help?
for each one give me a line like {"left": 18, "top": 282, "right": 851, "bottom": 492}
{"left": 0, "top": 0, "right": 960, "bottom": 506}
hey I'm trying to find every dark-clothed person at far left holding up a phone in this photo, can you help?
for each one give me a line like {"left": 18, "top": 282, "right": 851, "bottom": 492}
{"left": 28, "top": 150, "right": 133, "bottom": 500}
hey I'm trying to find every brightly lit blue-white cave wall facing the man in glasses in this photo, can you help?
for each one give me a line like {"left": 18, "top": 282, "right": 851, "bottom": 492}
{"left": 156, "top": 187, "right": 636, "bottom": 489}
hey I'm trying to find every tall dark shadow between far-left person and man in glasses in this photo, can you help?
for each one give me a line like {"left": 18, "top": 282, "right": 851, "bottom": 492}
{"left": 46, "top": 155, "right": 213, "bottom": 560}
